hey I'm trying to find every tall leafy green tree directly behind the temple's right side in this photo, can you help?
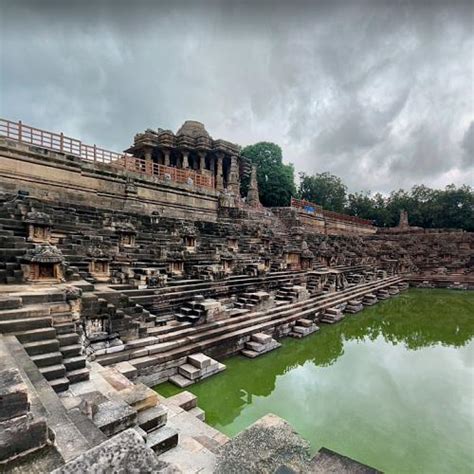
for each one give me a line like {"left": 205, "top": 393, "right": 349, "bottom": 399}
{"left": 241, "top": 142, "right": 296, "bottom": 207}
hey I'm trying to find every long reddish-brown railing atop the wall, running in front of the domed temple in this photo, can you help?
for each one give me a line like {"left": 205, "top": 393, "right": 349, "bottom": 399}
{"left": 0, "top": 118, "right": 214, "bottom": 188}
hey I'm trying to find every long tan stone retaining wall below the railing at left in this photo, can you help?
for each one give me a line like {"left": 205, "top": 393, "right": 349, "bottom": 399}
{"left": 0, "top": 138, "right": 218, "bottom": 221}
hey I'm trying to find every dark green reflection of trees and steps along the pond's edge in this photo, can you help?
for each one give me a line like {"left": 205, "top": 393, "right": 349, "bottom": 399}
{"left": 169, "top": 290, "right": 474, "bottom": 434}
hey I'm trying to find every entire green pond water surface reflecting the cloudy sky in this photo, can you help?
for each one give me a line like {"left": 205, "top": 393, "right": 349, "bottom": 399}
{"left": 157, "top": 290, "right": 474, "bottom": 473}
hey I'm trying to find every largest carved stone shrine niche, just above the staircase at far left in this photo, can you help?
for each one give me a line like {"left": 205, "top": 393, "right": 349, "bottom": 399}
{"left": 23, "top": 244, "right": 64, "bottom": 282}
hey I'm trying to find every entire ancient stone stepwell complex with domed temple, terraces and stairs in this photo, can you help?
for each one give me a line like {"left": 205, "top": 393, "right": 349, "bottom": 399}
{"left": 0, "top": 117, "right": 474, "bottom": 472}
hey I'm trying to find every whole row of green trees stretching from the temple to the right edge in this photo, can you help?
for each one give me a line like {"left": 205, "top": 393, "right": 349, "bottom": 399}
{"left": 242, "top": 142, "right": 474, "bottom": 231}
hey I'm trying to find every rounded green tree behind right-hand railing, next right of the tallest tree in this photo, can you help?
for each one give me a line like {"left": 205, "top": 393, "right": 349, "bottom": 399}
{"left": 300, "top": 171, "right": 347, "bottom": 212}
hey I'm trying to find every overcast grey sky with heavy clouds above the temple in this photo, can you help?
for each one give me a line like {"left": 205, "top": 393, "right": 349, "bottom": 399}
{"left": 0, "top": 0, "right": 474, "bottom": 192}
